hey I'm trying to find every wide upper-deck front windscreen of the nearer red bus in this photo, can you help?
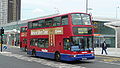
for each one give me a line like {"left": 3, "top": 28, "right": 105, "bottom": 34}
{"left": 71, "top": 13, "right": 91, "bottom": 25}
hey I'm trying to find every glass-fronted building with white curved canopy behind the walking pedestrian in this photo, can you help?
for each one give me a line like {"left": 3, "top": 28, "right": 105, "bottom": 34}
{"left": 93, "top": 17, "right": 120, "bottom": 48}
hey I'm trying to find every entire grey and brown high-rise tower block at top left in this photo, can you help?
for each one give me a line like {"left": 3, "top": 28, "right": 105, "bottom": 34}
{"left": 0, "top": 0, "right": 21, "bottom": 25}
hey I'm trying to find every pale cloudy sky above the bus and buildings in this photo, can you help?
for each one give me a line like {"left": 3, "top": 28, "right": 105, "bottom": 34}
{"left": 21, "top": 0, "right": 120, "bottom": 20}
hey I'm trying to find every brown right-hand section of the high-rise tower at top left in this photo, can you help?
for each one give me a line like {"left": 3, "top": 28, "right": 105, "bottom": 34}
{"left": 7, "top": 0, "right": 21, "bottom": 23}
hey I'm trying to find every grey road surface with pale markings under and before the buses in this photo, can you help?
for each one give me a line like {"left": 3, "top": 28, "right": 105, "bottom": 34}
{"left": 0, "top": 47, "right": 120, "bottom": 68}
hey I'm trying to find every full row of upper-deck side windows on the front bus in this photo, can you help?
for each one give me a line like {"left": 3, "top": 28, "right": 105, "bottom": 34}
{"left": 28, "top": 15, "right": 68, "bottom": 29}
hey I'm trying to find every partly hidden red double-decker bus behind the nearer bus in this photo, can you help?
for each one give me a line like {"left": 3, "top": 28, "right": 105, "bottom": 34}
{"left": 20, "top": 26, "right": 27, "bottom": 51}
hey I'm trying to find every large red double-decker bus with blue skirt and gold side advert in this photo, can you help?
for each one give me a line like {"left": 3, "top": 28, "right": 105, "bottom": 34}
{"left": 27, "top": 12, "right": 95, "bottom": 61}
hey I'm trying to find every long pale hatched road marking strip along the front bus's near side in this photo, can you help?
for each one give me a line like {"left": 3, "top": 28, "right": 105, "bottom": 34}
{"left": 0, "top": 52, "right": 86, "bottom": 68}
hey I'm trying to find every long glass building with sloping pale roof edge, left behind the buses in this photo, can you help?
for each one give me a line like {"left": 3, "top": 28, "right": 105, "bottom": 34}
{"left": 0, "top": 14, "right": 58, "bottom": 45}
